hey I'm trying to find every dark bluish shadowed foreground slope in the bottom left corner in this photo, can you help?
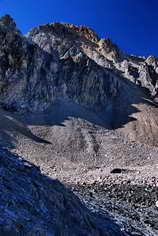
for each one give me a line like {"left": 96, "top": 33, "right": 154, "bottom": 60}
{"left": 0, "top": 149, "right": 124, "bottom": 236}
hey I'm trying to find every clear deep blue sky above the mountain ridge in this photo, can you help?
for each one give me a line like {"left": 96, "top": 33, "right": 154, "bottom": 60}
{"left": 0, "top": 0, "right": 158, "bottom": 57}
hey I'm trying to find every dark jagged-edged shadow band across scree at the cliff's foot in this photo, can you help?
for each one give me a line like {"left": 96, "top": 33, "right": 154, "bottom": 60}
{"left": 0, "top": 70, "right": 156, "bottom": 148}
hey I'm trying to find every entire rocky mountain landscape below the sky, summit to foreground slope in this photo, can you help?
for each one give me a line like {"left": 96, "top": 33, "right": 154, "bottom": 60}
{"left": 0, "top": 15, "right": 158, "bottom": 236}
